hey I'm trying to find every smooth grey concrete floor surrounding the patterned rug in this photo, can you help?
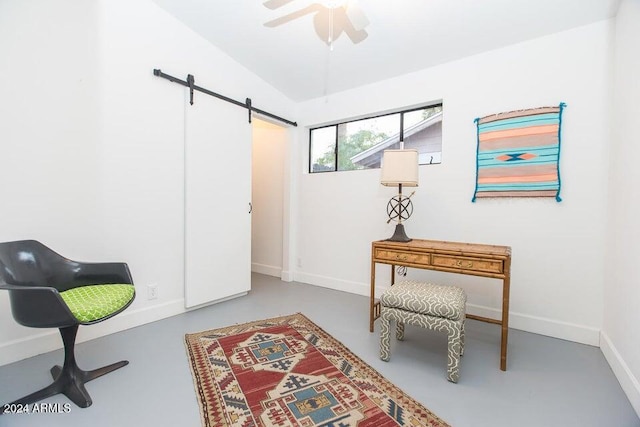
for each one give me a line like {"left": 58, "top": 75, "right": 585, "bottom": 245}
{"left": 0, "top": 274, "right": 640, "bottom": 427}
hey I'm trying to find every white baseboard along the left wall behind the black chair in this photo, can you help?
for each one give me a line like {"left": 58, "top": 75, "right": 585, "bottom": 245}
{"left": 0, "top": 299, "right": 186, "bottom": 366}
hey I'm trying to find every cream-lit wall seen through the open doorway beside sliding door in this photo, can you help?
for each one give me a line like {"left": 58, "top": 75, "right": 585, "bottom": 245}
{"left": 251, "top": 119, "right": 288, "bottom": 277}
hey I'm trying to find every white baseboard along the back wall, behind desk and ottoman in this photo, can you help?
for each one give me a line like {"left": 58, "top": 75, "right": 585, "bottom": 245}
{"left": 294, "top": 272, "right": 600, "bottom": 347}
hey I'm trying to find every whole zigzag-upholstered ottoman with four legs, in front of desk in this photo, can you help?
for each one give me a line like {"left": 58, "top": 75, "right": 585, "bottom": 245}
{"left": 380, "top": 281, "right": 467, "bottom": 383}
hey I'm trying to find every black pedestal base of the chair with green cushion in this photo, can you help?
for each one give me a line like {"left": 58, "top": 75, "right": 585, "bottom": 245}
{"left": 1, "top": 325, "right": 129, "bottom": 408}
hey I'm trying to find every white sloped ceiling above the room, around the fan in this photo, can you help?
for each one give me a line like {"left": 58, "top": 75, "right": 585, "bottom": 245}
{"left": 154, "top": 0, "right": 620, "bottom": 101}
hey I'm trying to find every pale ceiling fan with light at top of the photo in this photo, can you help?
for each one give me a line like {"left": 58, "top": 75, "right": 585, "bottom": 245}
{"left": 263, "top": 0, "right": 369, "bottom": 48}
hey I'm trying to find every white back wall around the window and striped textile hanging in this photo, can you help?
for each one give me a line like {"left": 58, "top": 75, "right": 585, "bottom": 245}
{"left": 294, "top": 21, "right": 611, "bottom": 345}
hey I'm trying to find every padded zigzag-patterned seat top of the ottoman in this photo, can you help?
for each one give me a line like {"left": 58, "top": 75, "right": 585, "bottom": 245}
{"left": 380, "top": 281, "right": 467, "bottom": 320}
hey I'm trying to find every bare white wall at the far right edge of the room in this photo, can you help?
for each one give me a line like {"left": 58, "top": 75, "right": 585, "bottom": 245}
{"left": 601, "top": 0, "right": 640, "bottom": 415}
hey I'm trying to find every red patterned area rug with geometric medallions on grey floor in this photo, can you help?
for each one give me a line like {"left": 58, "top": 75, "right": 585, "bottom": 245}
{"left": 185, "top": 313, "right": 448, "bottom": 427}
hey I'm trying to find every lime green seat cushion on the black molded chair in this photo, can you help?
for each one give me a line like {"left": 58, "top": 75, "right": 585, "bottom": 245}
{"left": 60, "top": 284, "right": 135, "bottom": 323}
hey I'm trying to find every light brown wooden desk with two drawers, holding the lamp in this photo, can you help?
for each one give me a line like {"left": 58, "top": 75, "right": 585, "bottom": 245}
{"left": 369, "top": 239, "right": 511, "bottom": 371}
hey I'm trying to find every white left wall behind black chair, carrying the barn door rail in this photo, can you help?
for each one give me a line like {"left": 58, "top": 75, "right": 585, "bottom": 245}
{"left": 0, "top": 0, "right": 293, "bottom": 364}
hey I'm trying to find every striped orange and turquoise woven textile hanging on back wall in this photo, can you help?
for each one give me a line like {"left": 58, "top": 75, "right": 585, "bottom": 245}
{"left": 472, "top": 103, "right": 566, "bottom": 202}
